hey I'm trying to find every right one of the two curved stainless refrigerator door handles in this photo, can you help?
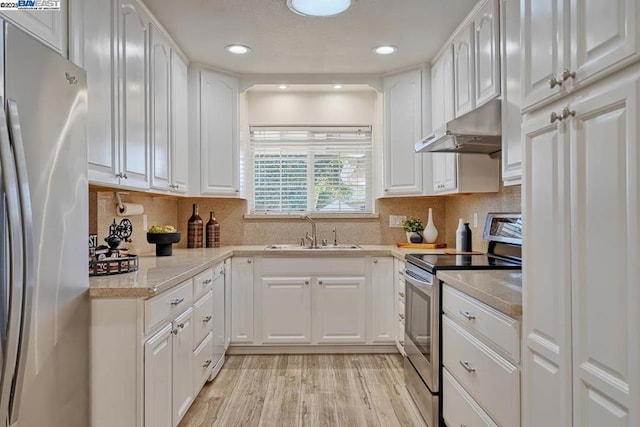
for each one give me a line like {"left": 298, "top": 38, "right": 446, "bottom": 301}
{"left": 7, "top": 99, "right": 36, "bottom": 425}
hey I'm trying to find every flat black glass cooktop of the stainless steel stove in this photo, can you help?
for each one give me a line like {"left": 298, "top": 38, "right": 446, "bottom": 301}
{"left": 405, "top": 254, "right": 522, "bottom": 273}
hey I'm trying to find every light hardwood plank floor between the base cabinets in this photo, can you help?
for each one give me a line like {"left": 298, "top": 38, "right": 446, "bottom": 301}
{"left": 180, "top": 354, "right": 425, "bottom": 427}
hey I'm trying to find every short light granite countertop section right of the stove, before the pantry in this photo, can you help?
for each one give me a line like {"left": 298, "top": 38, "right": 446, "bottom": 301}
{"left": 436, "top": 270, "right": 522, "bottom": 319}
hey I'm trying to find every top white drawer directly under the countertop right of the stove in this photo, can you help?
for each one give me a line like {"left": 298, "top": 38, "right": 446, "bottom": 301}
{"left": 442, "top": 284, "right": 520, "bottom": 363}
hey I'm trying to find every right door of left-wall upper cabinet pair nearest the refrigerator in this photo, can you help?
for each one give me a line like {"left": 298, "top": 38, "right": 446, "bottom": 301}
{"left": 114, "top": 0, "right": 149, "bottom": 189}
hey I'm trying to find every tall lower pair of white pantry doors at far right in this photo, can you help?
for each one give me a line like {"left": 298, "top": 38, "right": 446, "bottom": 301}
{"left": 522, "top": 65, "right": 640, "bottom": 427}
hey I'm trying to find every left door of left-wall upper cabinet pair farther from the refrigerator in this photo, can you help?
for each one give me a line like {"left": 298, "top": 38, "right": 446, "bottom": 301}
{"left": 151, "top": 25, "right": 171, "bottom": 190}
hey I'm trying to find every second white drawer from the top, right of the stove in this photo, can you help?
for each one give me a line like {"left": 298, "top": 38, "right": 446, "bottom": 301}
{"left": 442, "top": 315, "right": 520, "bottom": 426}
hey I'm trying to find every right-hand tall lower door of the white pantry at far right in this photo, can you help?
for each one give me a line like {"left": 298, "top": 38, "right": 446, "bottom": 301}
{"left": 568, "top": 77, "right": 640, "bottom": 426}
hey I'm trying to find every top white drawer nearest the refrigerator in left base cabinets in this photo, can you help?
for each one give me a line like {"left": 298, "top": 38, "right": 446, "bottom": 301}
{"left": 144, "top": 279, "right": 193, "bottom": 334}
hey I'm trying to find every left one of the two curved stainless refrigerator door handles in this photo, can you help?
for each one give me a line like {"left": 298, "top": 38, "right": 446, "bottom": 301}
{"left": 0, "top": 98, "right": 24, "bottom": 424}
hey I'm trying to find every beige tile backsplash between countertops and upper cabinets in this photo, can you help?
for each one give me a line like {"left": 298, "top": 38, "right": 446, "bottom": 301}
{"left": 89, "top": 186, "right": 520, "bottom": 254}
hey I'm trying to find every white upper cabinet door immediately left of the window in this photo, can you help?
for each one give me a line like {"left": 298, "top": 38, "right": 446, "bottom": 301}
{"left": 200, "top": 70, "right": 240, "bottom": 196}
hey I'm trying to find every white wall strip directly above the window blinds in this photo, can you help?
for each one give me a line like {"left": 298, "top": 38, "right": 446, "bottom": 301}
{"left": 246, "top": 89, "right": 377, "bottom": 127}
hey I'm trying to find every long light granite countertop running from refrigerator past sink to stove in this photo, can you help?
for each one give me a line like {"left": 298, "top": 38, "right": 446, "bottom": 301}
{"left": 89, "top": 245, "right": 442, "bottom": 298}
